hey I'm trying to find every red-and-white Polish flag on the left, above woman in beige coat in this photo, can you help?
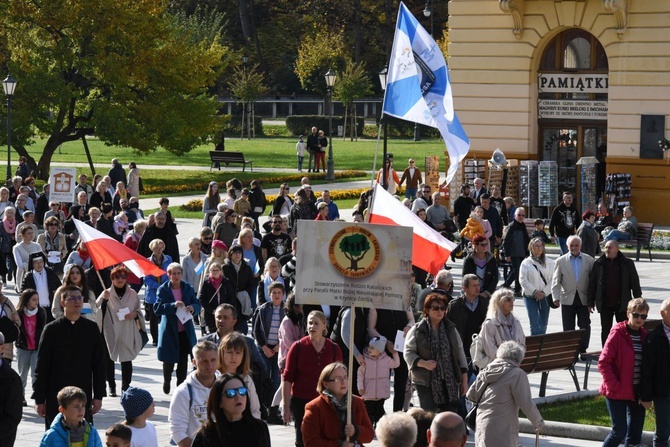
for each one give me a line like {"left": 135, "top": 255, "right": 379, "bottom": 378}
{"left": 73, "top": 219, "right": 165, "bottom": 278}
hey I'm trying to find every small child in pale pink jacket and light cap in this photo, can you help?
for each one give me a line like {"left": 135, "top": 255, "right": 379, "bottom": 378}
{"left": 357, "top": 337, "right": 400, "bottom": 426}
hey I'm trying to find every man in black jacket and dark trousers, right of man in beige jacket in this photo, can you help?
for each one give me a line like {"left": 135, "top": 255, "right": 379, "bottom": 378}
{"left": 588, "top": 241, "right": 642, "bottom": 346}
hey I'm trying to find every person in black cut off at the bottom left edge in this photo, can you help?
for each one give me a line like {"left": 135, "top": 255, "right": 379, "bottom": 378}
{"left": 0, "top": 332, "right": 23, "bottom": 446}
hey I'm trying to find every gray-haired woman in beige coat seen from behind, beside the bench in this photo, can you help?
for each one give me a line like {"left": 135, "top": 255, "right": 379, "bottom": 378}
{"left": 466, "top": 341, "right": 544, "bottom": 447}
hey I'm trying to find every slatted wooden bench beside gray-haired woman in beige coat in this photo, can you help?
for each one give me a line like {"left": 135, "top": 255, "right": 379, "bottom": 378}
{"left": 519, "top": 329, "right": 584, "bottom": 397}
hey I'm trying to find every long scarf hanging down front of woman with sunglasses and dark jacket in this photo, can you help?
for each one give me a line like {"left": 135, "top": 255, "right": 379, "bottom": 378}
{"left": 428, "top": 321, "right": 460, "bottom": 405}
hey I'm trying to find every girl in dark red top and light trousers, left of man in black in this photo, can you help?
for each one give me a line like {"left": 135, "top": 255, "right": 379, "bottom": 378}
{"left": 16, "top": 289, "right": 47, "bottom": 406}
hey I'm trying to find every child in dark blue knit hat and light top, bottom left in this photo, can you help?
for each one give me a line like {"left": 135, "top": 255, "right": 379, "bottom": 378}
{"left": 121, "top": 386, "right": 158, "bottom": 447}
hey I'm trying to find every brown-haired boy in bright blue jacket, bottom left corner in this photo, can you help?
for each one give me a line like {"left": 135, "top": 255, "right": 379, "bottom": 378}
{"left": 40, "top": 386, "right": 102, "bottom": 447}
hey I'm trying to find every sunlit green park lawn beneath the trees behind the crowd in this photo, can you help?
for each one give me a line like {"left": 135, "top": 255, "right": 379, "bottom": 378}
{"left": 43, "top": 138, "right": 452, "bottom": 170}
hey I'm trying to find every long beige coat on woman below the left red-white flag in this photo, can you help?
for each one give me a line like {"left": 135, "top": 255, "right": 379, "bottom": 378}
{"left": 97, "top": 286, "right": 146, "bottom": 362}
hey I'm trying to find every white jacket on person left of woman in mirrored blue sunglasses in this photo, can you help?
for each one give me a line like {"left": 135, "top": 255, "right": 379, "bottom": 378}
{"left": 168, "top": 371, "right": 219, "bottom": 444}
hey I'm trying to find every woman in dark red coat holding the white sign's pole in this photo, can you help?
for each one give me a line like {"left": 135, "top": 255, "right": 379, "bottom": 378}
{"left": 302, "top": 362, "right": 375, "bottom": 447}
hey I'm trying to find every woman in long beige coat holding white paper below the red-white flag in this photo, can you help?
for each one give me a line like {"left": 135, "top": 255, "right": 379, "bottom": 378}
{"left": 97, "top": 265, "right": 146, "bottom": 397}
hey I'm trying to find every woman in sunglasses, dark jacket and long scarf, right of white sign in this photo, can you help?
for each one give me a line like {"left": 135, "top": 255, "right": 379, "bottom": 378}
{"left": 404, "top": 293, "right": 468, "bottom": 413}
